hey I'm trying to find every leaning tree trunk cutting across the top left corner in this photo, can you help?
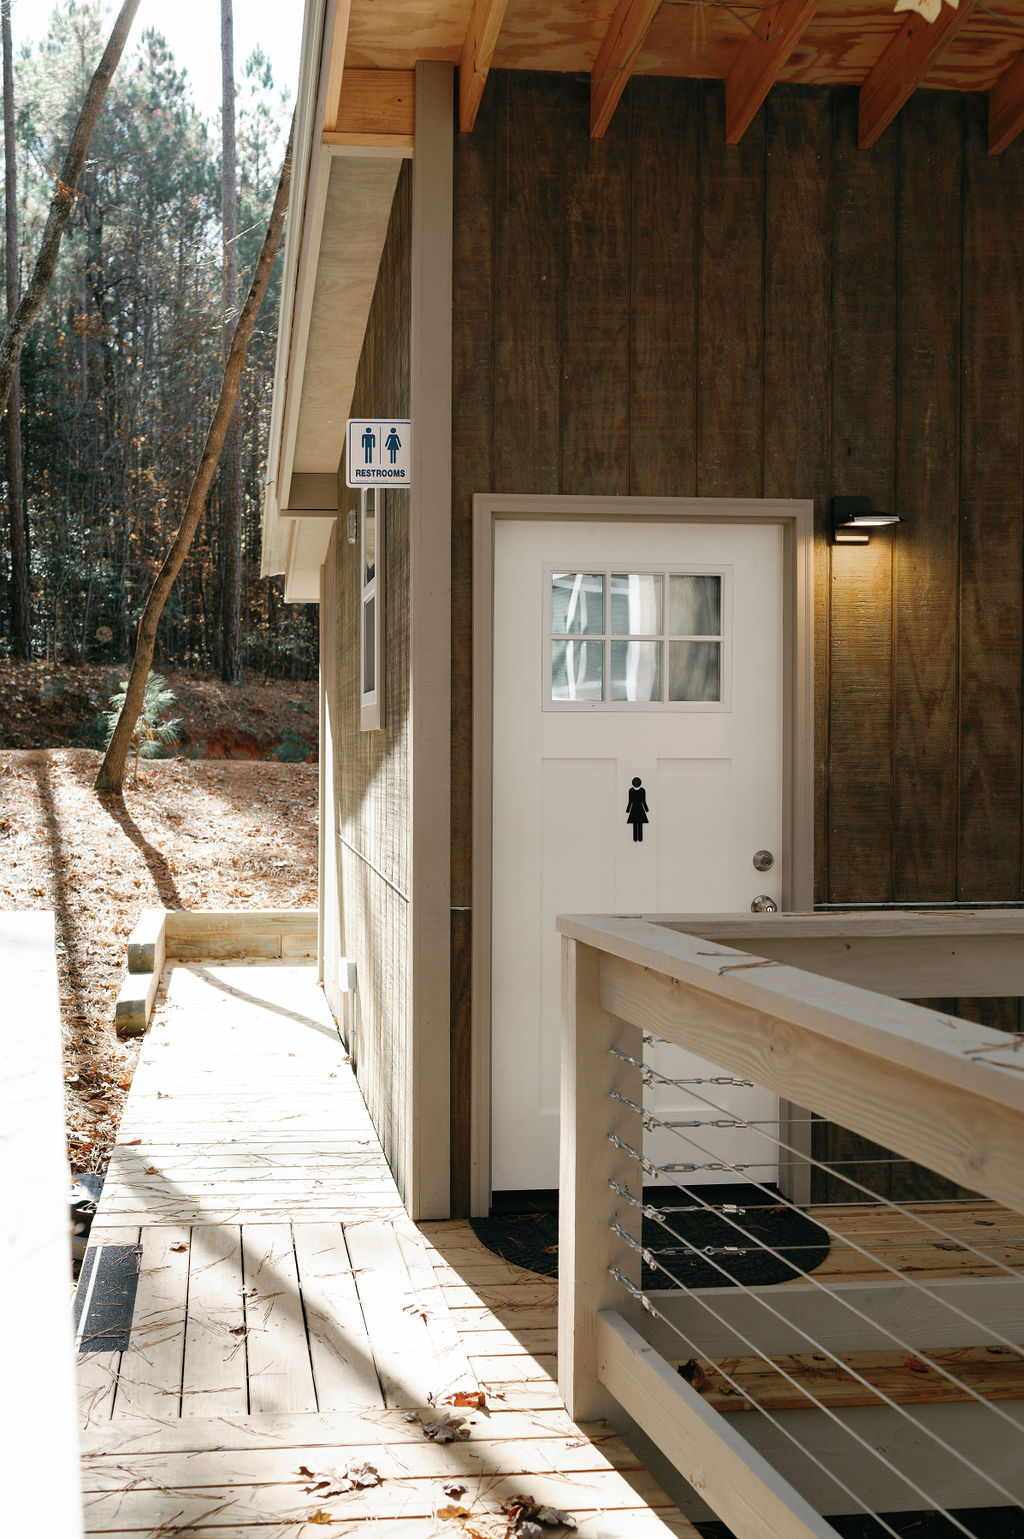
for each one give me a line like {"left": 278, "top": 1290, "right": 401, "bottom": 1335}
{"left": 0, "top": 0, "right": 139, "bottom": 427}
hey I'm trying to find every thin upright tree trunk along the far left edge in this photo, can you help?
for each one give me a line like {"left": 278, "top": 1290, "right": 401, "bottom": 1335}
{"left": 0, "top": 0, "right": 32, "bottom": 659}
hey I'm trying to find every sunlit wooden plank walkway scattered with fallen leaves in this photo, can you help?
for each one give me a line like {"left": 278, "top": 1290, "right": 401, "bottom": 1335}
{"left": 77, "top": 963, "right": 696, "bottom": 1539}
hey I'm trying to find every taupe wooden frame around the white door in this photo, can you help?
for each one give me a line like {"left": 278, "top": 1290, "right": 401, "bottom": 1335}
{"left": 470, "top": 492, "right": 815, "bottom": 1217}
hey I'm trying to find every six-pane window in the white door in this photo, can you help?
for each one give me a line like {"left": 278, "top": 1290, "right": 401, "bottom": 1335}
{"left": 545, "top": 568, "right": 728, "bottom": 709}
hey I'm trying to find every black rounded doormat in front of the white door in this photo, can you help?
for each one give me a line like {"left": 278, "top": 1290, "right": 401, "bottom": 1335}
{"left": 470, "top": 1185, "right": 828, "bottom": 1288}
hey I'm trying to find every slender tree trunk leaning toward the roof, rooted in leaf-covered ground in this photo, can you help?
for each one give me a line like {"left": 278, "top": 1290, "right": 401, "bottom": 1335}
{"left": 95, "top": 119, "right": 296, "bottom": 796}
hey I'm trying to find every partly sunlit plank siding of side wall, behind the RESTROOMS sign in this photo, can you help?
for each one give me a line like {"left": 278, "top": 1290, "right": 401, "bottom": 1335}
{"left": 320, "top": 163, "right": 411, "bottom": 1187}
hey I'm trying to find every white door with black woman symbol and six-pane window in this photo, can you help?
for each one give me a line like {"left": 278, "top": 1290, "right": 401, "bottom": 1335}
{"left": 491, "top": 519, "right": 782, "bottom": 1191}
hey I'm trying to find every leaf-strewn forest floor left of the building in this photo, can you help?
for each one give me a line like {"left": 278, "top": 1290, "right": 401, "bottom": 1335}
{"left": 0, "top": 732, "right": 317, "bottom": 1173}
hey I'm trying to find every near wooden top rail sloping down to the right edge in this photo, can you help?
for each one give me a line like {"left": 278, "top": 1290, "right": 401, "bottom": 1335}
{"left": 557, "top": 914, "right": 1024, "bottom": 1211}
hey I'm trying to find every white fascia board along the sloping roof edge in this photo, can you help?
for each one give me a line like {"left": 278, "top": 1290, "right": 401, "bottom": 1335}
{"left": 260, "top": 0, "right": 336, "bottom": 577}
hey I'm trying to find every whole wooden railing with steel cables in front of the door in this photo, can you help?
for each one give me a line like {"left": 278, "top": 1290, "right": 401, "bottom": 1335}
{"left": 559, "top": 911, "right": 1024, "bottom": 1539}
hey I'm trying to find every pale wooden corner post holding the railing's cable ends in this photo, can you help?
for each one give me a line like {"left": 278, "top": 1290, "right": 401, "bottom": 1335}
{"left": 559, "top": 936, "right": 644, "bottom": 1422}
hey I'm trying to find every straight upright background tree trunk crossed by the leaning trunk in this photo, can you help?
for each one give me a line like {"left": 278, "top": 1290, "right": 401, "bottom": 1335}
{"left": 220, "top": 0, "right": 242, "bottom": 683}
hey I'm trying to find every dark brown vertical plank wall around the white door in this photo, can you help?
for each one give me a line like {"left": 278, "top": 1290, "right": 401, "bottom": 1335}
{"left": 451, "top": 72, "right": 1024, "bottom": 1211}
